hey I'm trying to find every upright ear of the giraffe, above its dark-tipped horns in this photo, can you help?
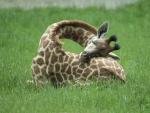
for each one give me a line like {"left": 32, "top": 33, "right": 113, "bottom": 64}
{"left": 97, "top": 22, "right": 108, "bottom": 38}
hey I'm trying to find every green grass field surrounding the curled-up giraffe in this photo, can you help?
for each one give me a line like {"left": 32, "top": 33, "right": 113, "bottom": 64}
{"left": 0, "top": 0, "right": 150, "bottom": 113}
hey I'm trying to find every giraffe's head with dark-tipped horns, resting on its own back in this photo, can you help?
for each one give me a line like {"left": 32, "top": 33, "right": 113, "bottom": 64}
{"left": 81, "top": 22, "right": 120, "bottom": 62}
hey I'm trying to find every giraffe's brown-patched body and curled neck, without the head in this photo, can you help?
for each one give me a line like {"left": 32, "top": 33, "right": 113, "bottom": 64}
{"left": 31, "top": 20, "right": 126, "bottom": 86}
